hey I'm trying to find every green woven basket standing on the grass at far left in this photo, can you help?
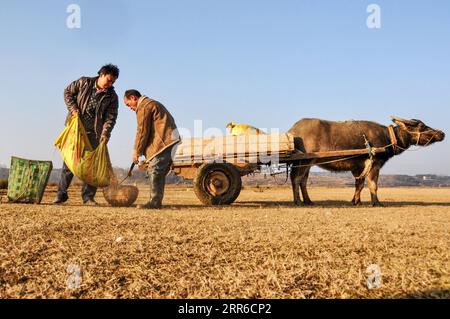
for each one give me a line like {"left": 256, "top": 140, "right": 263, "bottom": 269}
{"left": 7, "top": 157, "right": 53, "bottom": 204}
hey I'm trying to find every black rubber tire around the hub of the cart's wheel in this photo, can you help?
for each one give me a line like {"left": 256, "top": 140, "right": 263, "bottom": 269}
{"left": 194, "top": 163, "right": 242, "bottom": 205}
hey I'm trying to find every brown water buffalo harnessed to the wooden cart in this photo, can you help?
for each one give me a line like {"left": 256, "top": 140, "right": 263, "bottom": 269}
{"left": 289, "top": 117, "right": 445, "bottom": 206}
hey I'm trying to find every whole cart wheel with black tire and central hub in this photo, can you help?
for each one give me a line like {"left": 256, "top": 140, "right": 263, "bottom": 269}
{"left": 194, "top": 163, "right": 242, "bottom": 205}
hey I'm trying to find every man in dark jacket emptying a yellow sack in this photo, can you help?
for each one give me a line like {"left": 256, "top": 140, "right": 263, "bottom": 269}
{"left": 54, "top": 64, "right": 119, "bottom": 206}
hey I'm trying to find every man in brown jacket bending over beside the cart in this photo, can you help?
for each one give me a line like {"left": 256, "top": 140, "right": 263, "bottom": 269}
{"left": 124, "top": 90, "right": 181, "bottom": 209}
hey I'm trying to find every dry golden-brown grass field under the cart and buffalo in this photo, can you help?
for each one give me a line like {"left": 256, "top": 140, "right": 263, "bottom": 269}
{"left": 0, "top": 186, "right": 450, "bottom": 298}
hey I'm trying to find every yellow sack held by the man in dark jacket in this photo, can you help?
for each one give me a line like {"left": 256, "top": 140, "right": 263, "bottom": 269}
{"left": 54, "top": 115, "right": 113, "bottom": 187}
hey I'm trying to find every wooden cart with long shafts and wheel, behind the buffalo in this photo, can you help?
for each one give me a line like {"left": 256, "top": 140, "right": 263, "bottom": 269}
{"left": 172, "top": 133, "right": 386, "bottom": 205}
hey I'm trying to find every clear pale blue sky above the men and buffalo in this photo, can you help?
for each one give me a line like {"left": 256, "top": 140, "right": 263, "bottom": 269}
{"left": 0, "top": 0, "right": 450, "bottom": 174}
